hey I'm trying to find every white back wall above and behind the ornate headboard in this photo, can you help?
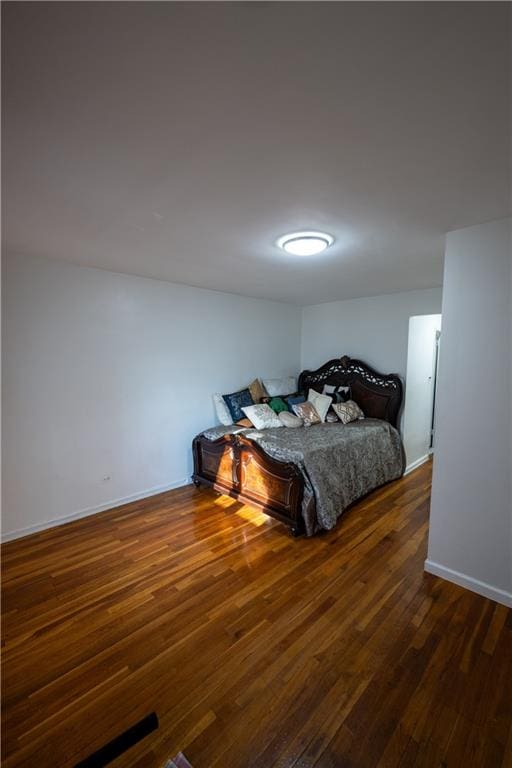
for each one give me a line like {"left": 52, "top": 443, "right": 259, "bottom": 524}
{"left": 301, "top": 288, "right": 442, "bottom": 378}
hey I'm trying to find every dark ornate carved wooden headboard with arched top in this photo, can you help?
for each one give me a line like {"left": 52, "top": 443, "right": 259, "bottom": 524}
{"left": 299, "top": 356, "right": 403, "bottom": 427}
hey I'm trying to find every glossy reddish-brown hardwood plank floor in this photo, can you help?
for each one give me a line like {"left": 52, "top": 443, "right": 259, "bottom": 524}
{"left": 2, "top": 465, "right": 512, "bottom": 768}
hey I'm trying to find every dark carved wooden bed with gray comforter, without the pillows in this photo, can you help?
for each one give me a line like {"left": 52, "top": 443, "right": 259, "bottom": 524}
{"left": 192, "top": 356, "right": 404, "bottom": 536}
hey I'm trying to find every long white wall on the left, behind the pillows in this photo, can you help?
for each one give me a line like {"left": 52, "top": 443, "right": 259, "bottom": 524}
{"left": 3, "top": 256, "right": 300, "bottom": 537}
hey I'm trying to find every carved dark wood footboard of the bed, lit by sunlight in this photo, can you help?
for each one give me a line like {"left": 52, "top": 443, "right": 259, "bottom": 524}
{"left": 192, "top": 435, "right": 304, "bottom": 536}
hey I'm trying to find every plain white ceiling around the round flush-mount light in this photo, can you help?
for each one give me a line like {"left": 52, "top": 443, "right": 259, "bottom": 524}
{"left": 2, "top": 2, "right": 511, "bottom": 304}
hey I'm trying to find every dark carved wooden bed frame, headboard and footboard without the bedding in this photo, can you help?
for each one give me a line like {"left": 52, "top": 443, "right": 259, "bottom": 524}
{"left": 192, "top": 357, "right": 403, "bottom": 536}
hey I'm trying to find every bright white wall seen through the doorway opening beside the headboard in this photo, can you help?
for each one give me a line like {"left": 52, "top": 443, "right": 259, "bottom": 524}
{"left": 403, "top": 315, "right": 441, "bottom": 472}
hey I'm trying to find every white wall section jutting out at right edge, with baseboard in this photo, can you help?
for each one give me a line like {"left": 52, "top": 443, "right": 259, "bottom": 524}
{"left": 425, "top": 219, "right": 512, "bottom": 605}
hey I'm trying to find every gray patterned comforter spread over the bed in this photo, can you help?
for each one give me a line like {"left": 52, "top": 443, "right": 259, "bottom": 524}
{"left": 203, "top": 419, "right": 404, "bottom": 535}
